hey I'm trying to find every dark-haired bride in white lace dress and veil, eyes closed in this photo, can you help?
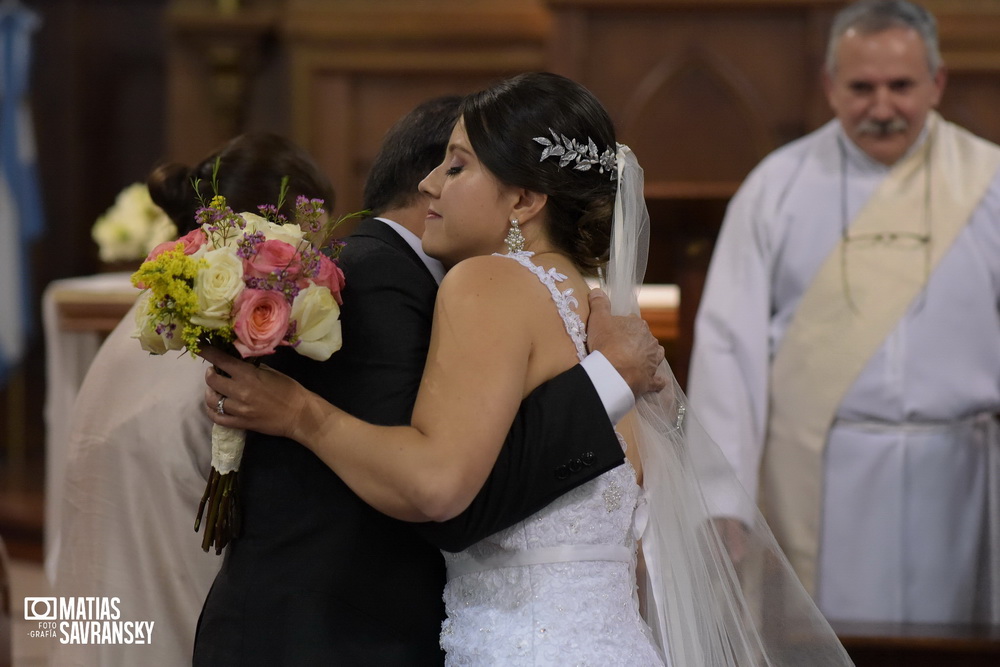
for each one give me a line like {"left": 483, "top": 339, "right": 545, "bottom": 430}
{"left": 204, "top": 73, "right": 850, "bottom": 667}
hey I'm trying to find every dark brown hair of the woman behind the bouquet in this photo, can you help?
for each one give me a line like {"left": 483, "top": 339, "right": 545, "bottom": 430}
{"left": 146, "top": 132, "right": 334, "bottom": 234}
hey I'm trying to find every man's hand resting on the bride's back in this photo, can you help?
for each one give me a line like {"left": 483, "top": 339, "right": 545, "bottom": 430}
{"left": 587, "top": 289, "right": 667, "bottom": 396}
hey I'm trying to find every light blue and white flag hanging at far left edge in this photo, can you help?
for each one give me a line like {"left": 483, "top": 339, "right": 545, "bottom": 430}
{"left": 0, "top": 1, "right": 44, "bottom": 387}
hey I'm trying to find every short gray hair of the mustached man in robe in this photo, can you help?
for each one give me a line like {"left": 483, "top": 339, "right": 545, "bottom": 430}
{"left": 826, "top": 0, "right": 942, "bottom": 75}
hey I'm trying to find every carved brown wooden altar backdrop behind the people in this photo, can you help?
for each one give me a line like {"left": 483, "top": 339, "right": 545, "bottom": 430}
{"left": 168, "top": 0, "right": 1000, "bottom": 384}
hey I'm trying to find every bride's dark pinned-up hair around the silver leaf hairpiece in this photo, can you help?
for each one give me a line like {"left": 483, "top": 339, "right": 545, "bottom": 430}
{"left": 461, "top": 72, "right": 616, "bottom": 273}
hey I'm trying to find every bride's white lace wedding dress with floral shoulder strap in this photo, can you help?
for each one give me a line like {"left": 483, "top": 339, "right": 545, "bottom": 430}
{"left": 441, "top": 252, "right": 664, "bottom": 667}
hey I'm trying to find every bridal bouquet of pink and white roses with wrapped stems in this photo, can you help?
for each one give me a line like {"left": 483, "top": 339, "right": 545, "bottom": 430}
{"left": 132, "top": 177, "right": 358, "bottom": 554}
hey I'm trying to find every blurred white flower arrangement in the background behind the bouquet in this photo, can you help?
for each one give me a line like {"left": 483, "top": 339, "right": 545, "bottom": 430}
{"left": 90, "top": 183, "right": 177, "bottom": 263}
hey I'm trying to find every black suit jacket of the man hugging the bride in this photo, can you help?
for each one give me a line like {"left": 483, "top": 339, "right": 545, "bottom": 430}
{"left": 194, "top": 220, "right": 623, "bottom": 667}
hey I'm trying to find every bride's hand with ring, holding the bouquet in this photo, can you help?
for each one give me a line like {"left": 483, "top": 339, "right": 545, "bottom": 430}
{"left": 200, "top": 347, "right": 308, "bottom": 438}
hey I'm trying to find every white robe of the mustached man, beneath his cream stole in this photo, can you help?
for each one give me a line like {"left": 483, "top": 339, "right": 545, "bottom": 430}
{"left": 689, "top": 120, "right": 1000, "bottom": 622}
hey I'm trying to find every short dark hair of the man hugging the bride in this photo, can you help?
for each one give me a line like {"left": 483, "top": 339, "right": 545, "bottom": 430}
{"left": 363, "top": 95, "right": 462, "bottom": 215}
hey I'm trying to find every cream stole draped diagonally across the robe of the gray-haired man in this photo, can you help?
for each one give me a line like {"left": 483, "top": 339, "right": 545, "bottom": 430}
{"left": 761, "top": 113, "right": 1000, "bottom": 595}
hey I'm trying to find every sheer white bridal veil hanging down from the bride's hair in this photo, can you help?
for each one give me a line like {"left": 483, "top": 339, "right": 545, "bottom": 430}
{"left": 603, "top": 145, "right": 853, "bottom": 667}
